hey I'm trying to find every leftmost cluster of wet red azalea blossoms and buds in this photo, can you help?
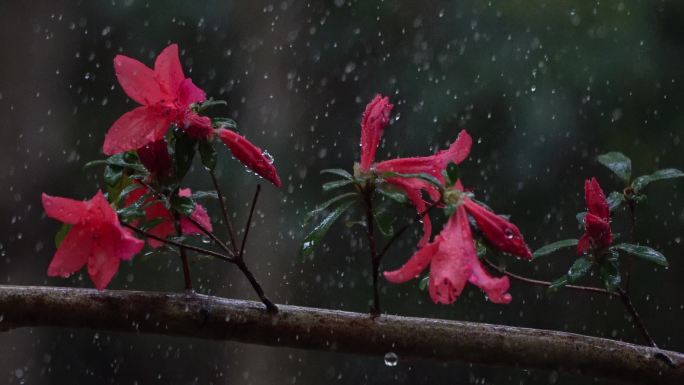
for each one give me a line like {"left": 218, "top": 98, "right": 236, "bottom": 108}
{"left": 42, "top": 44, "right": 281, "bottom": 290}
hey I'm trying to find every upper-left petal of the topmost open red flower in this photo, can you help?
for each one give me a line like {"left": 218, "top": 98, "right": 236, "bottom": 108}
{"left": 114, "top": 55, "right": 168, "bottom": 105}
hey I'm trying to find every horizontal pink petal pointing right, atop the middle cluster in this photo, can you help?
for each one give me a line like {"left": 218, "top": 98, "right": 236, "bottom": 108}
{"left": 375, "top": 130, "right": 473, "bottom": 181}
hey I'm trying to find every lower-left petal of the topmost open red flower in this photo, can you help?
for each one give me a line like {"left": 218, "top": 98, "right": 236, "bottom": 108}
{"left": 102, "top": 106, "right": 174, "bottom": 155}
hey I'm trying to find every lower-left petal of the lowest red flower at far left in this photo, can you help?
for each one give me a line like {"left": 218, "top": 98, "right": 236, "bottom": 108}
{"left": 48, "top": 225, "right": 92, "bottom": 277}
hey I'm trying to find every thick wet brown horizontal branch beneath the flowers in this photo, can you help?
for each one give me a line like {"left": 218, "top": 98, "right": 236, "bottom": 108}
{"left": 0, "top": 285, "right": 684, "bottom": 384}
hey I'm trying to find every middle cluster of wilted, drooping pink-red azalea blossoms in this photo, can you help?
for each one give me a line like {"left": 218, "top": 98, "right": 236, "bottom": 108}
{"left": 352, "top": 95, "right": 532, "bottom": 304}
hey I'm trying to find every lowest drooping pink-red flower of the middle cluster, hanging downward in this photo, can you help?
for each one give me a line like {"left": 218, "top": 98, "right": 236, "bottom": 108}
{"left": 384, "top": 181, "right": 532, "bottom": 304}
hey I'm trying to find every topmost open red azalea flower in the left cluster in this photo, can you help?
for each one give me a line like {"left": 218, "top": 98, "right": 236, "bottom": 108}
{"left": 103, "top": 44, "right": 213, "bottom": 155}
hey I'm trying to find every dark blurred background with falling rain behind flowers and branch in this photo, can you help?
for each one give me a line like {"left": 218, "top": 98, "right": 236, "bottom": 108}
{"left": 0, "top": 0, "right": 684, "bottom": 385}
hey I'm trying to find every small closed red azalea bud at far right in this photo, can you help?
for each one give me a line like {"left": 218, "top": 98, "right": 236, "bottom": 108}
{"left": 577, "top": 178, "right": 613, "bottom": 255}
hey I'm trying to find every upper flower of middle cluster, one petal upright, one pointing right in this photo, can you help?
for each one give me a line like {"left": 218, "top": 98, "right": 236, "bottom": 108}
{"left": 359, "top": 95, "right": 472, "bottom": 246}
